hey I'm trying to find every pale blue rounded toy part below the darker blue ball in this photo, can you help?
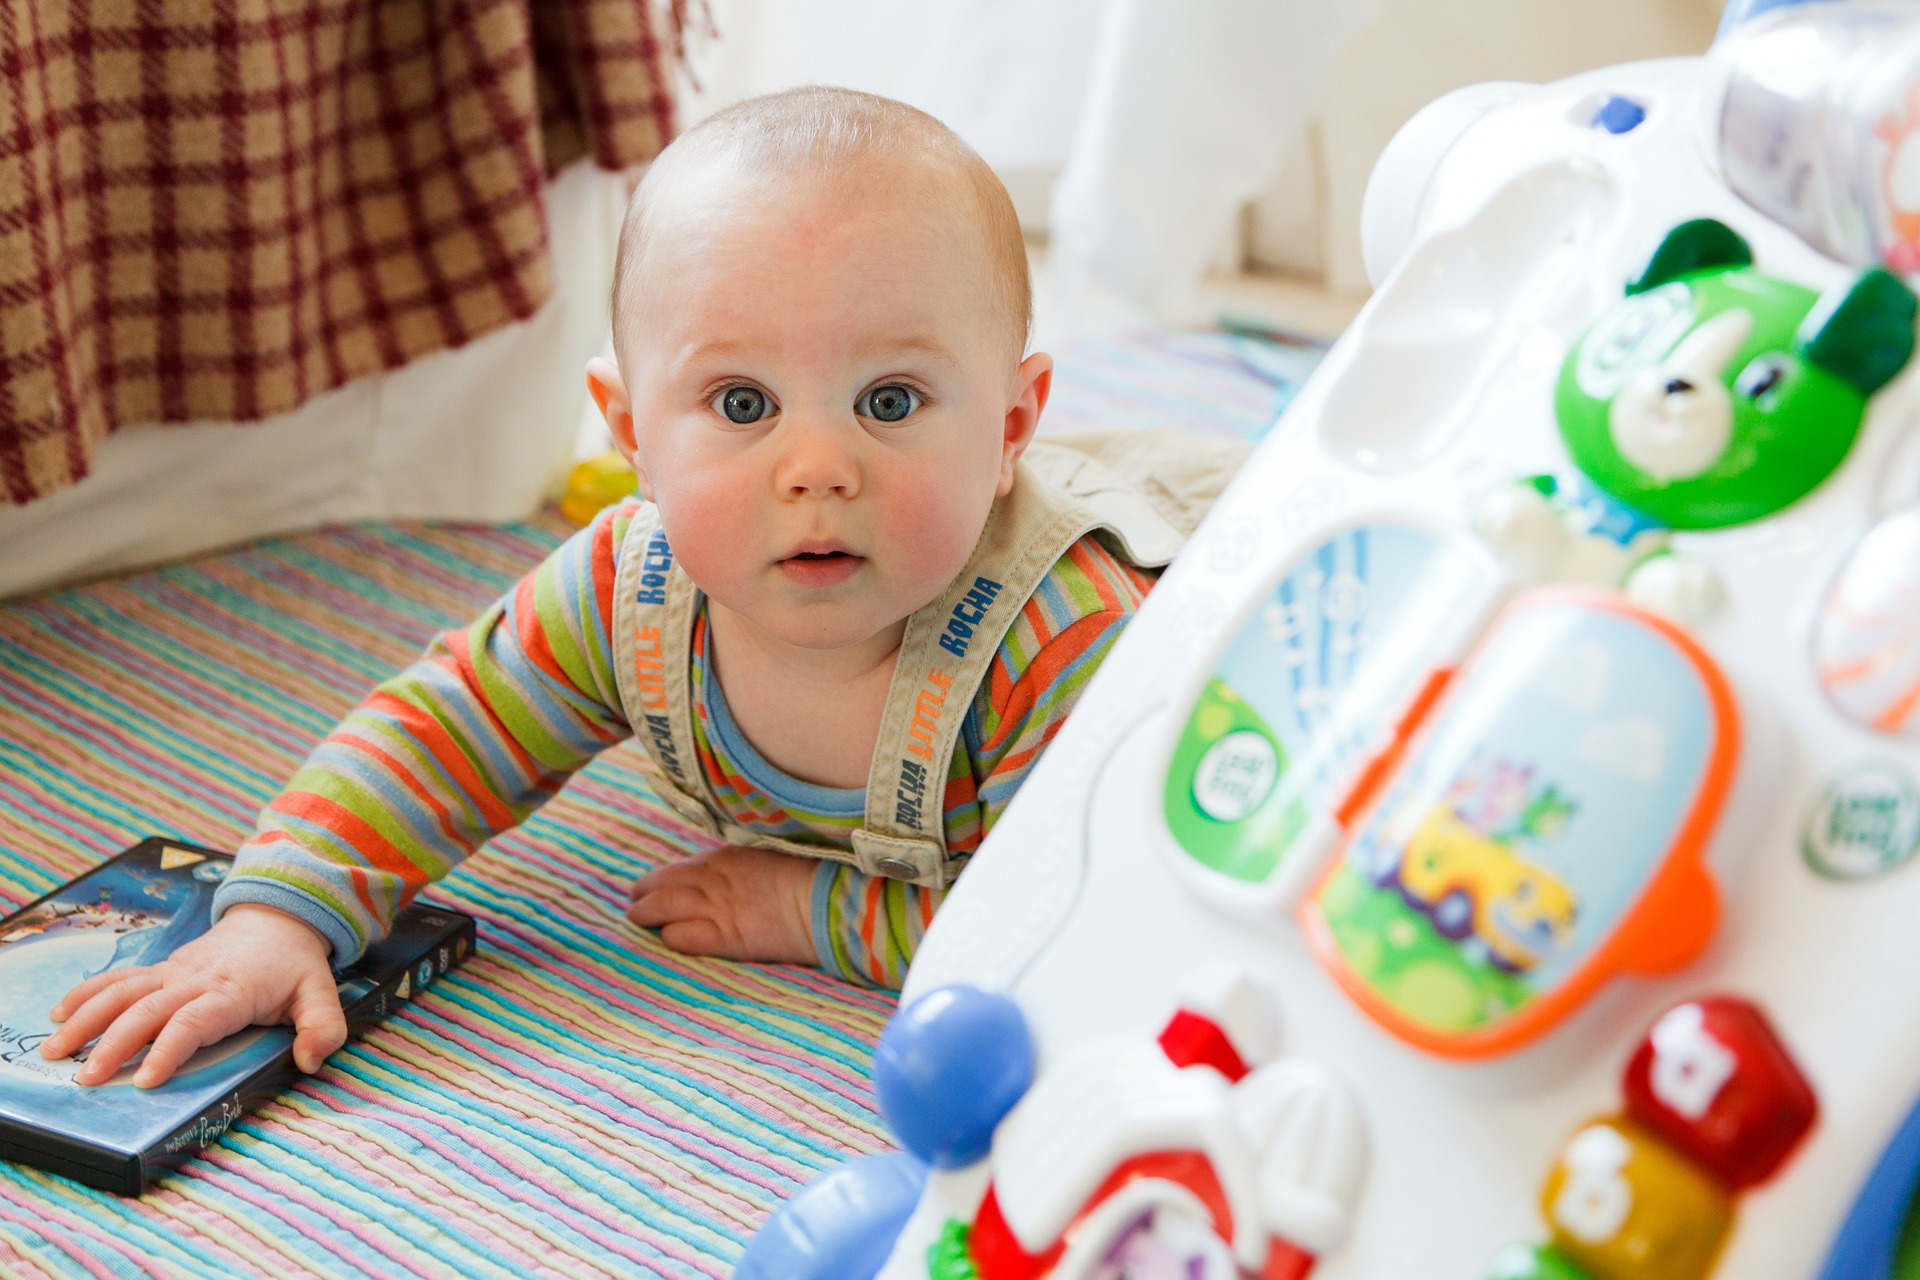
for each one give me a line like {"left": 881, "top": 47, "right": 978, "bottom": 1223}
{"left": 733, "top": 1151, "right": 927, "bottom": 1280}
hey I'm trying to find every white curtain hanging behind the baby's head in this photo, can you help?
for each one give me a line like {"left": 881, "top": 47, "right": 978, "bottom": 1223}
{"left": 693, "top": 0, "right": 1371, "bottom": 332}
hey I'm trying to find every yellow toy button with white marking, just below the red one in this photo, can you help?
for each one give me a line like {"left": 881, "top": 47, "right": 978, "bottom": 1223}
{"left": 1540, "top": 1119, "right": 1734, "bottom": 1280}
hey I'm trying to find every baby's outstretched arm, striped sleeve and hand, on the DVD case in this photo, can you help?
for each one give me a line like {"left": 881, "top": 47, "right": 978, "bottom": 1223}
{"left": 42, "top": 507, "right": 634, "bottom": 1084}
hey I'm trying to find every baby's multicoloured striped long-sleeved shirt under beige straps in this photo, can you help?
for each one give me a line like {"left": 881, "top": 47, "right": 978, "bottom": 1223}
{"left": 215, "top": 503, "right": 1154, "bottom": 986}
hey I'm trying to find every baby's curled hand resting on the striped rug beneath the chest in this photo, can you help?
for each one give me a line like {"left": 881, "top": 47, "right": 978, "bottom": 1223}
{"left": 626, "top": 844, "right": 820, "bottom": 965}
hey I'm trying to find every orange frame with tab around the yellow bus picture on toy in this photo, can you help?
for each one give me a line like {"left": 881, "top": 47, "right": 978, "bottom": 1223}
{"left": 1298, "top": 587, "right": 1741, "bottom": 1059}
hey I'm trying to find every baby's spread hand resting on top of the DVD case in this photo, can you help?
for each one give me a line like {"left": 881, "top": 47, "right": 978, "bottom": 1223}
{"left": 40, "top": 904, "right": 348, "bottom": 1088}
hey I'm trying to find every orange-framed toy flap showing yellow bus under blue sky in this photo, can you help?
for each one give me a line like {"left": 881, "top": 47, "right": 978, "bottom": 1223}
{"left": 1300, "top": 587, "right": 1740, "bottom": 1057}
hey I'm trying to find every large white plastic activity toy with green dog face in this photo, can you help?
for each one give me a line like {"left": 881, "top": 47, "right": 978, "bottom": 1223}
{"left": 741, "top": 0, "right": 1920, "bottom": 1280}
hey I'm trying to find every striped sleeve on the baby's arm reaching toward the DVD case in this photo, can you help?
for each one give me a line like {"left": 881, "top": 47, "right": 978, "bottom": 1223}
{"left": 213, "top": 507, "right": 634, "bottom": 965}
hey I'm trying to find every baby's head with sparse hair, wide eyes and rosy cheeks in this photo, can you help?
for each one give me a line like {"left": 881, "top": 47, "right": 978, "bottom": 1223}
{"left": 588, "top": 88, "right": 1052, "bottom": 649}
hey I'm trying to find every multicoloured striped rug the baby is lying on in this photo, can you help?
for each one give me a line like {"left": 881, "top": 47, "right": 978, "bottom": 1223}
{"left": 0, "top": 336, "right": 1311, "bottom": 1278}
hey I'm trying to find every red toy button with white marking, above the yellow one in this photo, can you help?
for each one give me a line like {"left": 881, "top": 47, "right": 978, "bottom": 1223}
{"left": 1624, "top": 996, "right": 1820, "bottom": 1190}
